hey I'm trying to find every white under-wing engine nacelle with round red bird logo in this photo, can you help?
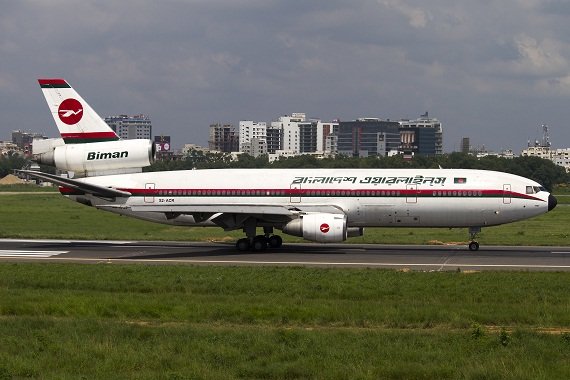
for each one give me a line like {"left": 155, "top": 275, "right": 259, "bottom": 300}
{"left": 282, "top": 213, "right": 347, "bottom": 243}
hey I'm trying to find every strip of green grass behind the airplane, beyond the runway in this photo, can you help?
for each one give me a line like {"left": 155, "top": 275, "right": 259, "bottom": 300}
{"left": 0, "top": 193, "right": 570, "bottom": 246}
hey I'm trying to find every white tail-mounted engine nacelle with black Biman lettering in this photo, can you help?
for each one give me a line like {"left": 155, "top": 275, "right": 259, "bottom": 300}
{"left": 34, "top": 140, "right": 156, "bottom": 174}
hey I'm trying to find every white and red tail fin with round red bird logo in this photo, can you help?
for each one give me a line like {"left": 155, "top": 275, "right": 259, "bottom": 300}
{"left": 38, "top": 79, "right": 119, "bottom": 144}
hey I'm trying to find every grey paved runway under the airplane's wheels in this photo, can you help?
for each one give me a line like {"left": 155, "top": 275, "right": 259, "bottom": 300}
{"left": 0, "top": 239, "right": 570, "bottom": 271}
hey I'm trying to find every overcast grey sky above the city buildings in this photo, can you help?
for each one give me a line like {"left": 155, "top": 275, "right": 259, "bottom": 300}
{"left": 0, "top": 0, "right": 570, "bottom": 153}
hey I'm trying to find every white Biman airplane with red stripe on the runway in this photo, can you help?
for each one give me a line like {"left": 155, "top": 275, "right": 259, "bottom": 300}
{"left": 23, "top": 79, "right": 557, "bottom": 251}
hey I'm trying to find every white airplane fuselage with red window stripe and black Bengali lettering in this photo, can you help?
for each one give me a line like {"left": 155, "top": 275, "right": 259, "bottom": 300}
{"left": 62, "top": 169, "right": 549, "bottom": 227}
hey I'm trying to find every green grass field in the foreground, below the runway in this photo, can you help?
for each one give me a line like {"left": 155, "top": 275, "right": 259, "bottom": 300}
{"left": 0, "top": 264, "right": 570, "bottom": 379}
